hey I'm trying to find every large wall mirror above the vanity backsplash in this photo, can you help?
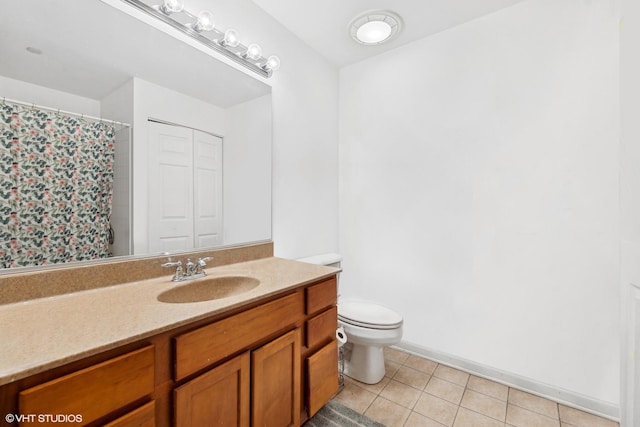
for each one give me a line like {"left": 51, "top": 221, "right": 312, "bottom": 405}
{"left": 0, "top": 0, "right": 272, "bottom": 274}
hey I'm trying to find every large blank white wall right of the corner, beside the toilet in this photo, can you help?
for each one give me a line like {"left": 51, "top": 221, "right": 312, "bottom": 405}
{"left": 340, "top": 0, "right": 619, "bottom": 415}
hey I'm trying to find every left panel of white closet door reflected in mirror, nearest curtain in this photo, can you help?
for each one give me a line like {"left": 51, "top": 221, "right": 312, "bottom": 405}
{"left": 148, "top": 121, "right": 194, "bottom": 253}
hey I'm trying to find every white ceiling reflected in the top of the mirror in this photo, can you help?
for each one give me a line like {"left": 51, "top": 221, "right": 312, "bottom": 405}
{"left": 0, "top": 0, "right": 270, "bottom": 108}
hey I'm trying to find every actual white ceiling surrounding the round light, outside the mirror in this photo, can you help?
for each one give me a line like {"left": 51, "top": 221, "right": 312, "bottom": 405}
{"left": 253, "top": 0, "right": 523, "bottom": 67}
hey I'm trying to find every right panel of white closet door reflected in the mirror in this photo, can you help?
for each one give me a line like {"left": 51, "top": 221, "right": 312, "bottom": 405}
{"left": 193, "top": 130, "right": 222, "bottom": 248}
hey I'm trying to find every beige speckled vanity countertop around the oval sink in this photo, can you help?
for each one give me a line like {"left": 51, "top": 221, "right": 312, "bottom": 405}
{"left": 0, "top": 257, "right": 340, "bottom": 385}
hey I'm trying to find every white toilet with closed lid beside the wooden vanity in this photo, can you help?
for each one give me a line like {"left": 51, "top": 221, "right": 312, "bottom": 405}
{"left": 298, "top": 254, "right": 402, "bottom": 384}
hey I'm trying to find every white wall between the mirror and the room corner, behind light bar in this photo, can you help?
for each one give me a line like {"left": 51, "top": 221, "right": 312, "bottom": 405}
{"left": 184, "top": 0, "right": 338, "bottom": 258}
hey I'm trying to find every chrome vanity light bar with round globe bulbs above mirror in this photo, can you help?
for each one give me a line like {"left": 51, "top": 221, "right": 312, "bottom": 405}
{"left": 122, "top": 0, "right": 280, "bottom": 78}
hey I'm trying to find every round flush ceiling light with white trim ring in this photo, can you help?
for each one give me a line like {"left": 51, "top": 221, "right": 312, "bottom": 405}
{"left": 349, "top": 10, "right": 402, "bottom": 45}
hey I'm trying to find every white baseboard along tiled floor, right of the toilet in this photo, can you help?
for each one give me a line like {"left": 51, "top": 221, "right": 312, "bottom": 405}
{"left": 393, "top": 341, "right": 620, "bottom": 422}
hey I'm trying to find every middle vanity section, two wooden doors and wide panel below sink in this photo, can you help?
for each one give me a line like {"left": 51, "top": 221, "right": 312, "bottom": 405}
{"left": 174, "top": 290, "right": 304, "bottom": 427}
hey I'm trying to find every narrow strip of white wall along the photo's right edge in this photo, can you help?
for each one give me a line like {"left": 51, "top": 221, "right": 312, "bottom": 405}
{"left": 620, "top": 0, "right": 640, "bottom": 426}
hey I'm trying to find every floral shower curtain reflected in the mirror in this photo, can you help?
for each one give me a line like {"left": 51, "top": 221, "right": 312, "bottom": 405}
{"left": 0, "top": 102, "right": 115, "bottom": 268}
